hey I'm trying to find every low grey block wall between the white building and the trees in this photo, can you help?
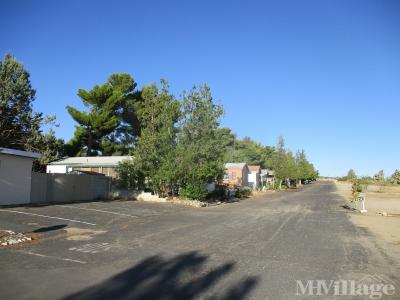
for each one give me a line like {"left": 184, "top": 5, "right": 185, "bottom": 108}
{"left": 30, "top": 173, "right": 111, "bottom": 204}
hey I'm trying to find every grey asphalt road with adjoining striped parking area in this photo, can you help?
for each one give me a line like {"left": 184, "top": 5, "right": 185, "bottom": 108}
{"left": 0, "top": 183, "right": 400, "bottom": 299}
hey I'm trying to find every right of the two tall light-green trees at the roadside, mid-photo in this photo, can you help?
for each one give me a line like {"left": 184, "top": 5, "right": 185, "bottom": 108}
{"left": 177, "top": 85, "right": 226, "bottom": 200}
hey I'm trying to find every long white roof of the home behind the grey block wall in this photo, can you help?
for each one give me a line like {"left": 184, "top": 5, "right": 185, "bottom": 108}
{"left": 49, "top": 156, "right": 132, "bottom": 166}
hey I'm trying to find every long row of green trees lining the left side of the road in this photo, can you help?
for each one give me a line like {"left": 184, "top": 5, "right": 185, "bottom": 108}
{"left": 0, "top": 54, "right": 318, "bottom": 199}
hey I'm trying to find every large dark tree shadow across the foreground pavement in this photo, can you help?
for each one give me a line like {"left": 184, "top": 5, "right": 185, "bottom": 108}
{"left": 64, "top": 252, "right": 258, "bottom": 300}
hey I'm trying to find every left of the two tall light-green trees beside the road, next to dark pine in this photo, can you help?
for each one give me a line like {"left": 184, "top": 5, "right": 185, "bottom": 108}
{"left": 133, "top": 80, "right": 180, "bottom": 195}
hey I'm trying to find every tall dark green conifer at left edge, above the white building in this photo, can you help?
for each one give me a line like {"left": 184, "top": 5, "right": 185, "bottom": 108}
{"left": 0, "top": 54, "right": 43, "bottom": 150}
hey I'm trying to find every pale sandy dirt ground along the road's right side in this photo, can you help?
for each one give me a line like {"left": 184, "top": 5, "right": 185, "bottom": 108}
{"left": 336, "top": 182, "right": 400, "bottom": 247}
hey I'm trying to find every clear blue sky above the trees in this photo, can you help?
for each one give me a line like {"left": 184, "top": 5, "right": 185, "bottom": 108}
{"left": 0, "top": 0, "right": 400, "bottom": 175}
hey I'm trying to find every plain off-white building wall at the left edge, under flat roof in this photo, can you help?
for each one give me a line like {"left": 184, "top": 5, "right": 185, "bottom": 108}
{"left": 0, "top": 154, "right": 33, "bottom": 205}
